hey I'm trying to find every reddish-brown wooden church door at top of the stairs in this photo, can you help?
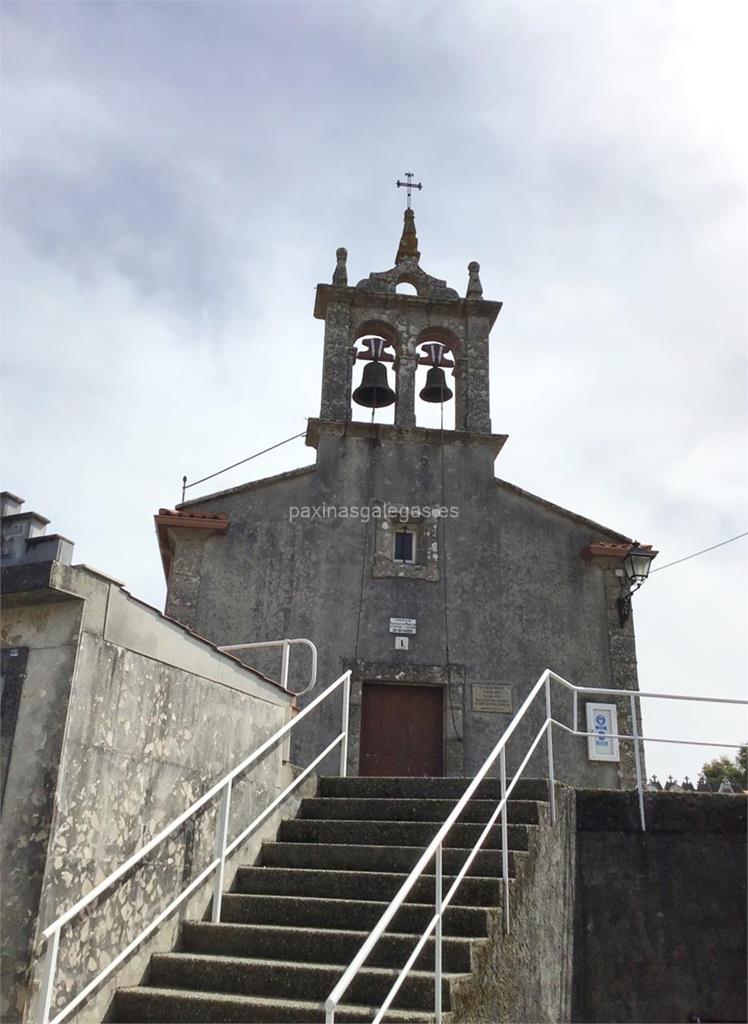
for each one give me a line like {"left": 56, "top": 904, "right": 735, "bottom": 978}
{"left": 360, "top": 683, "right": 444, "bottom": 776}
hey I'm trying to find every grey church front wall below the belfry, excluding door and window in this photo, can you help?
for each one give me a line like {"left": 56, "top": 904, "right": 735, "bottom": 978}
{"left": 172, "top": 424, "right": 636, "bottom": 787}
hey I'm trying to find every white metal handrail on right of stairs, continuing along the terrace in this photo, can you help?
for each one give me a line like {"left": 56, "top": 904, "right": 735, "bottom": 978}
{"left": 325, "top": 669, "right": 748, "bottom": 1024}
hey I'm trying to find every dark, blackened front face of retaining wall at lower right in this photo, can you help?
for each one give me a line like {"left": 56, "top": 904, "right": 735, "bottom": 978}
{"left": 573, "top": 792, "right": 748, "bottom": 1022}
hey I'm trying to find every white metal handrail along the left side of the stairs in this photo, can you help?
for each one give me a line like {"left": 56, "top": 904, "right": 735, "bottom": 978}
{"left": 37, "top": 663, "right": 350, "bottom": 1024}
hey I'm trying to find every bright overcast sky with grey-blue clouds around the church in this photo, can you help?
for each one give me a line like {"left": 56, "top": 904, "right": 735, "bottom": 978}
{"left": 2, "top": 0, "right": 748, "bottom": 776}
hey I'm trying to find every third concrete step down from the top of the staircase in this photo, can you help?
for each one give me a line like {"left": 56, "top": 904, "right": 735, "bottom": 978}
{"left": 279, "top": 818, "right": 536, "bottom": 850}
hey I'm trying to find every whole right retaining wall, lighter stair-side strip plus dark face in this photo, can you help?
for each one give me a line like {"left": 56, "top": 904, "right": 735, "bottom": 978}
{"left": 450, "top": 787, "right": 748, "bottom": 1024}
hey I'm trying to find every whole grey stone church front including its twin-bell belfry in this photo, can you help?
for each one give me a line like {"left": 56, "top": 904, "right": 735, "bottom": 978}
{"left": 156, "top": 209, "right": 651, "bottom": 787}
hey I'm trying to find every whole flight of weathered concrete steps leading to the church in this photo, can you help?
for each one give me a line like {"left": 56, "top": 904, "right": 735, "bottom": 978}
{"left": 108, "top": 778, "right": 548, "bottom": 1024}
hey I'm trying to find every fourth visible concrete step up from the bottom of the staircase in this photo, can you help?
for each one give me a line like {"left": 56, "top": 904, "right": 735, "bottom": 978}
{"left": 221, "top": 893, "right": 492, "bottom": 937}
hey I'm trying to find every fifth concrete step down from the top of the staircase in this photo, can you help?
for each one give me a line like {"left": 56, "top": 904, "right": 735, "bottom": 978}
{"left": 232, "top": 867, "right": 500, "bottom": 906}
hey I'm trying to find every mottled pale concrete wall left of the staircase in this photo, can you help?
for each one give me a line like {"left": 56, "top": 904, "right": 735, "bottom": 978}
{"left": 1, "top": 563, "right": 295, "bottom": 1022}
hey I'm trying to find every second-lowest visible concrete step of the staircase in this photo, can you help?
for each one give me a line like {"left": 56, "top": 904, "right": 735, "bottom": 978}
{"left": 149, "top": 953, "right": 457, "bottom": 1011}
